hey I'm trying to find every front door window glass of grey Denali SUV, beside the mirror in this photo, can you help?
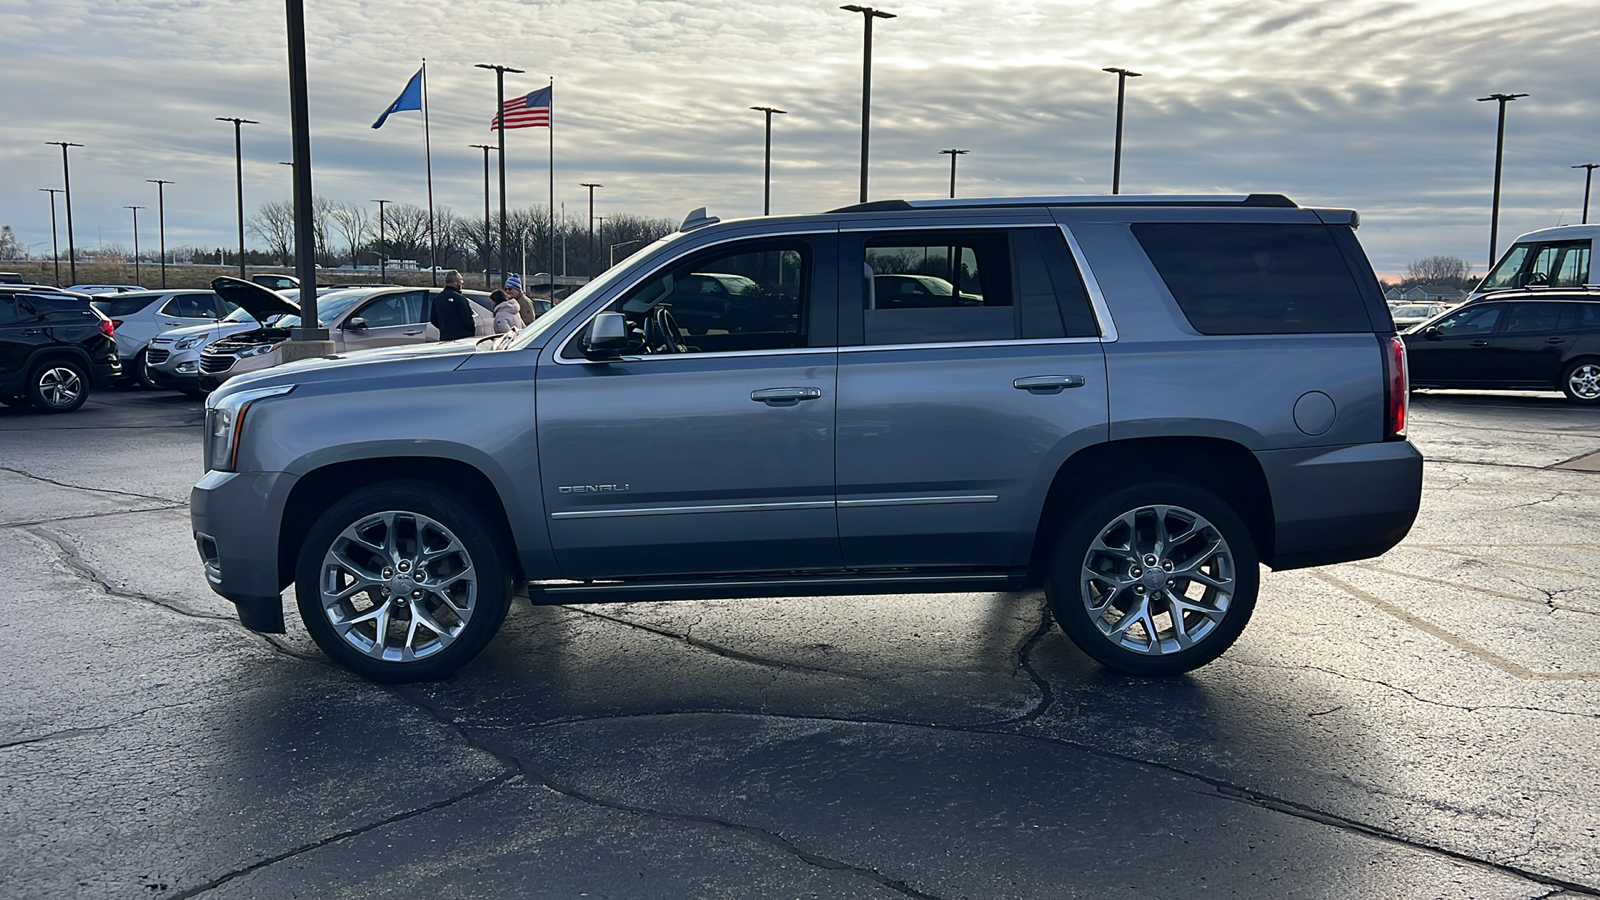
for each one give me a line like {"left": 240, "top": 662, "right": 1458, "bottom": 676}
{"left": 563, "top": 240, "right": 813, "bottom": 359}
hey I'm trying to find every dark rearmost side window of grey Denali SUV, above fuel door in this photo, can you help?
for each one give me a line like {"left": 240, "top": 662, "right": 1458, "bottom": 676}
{"left": 1133, "top": 223, "right": 1373, "bottom": 335}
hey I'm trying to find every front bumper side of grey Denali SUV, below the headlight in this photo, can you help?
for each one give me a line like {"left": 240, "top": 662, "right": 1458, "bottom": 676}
{"left": 189, "top": 472, "right": 296, "bottom": 634}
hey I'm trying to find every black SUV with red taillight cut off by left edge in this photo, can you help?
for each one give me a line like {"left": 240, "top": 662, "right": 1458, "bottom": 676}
{"left": 0, "top": 285, "right": 122, "bottom": 413}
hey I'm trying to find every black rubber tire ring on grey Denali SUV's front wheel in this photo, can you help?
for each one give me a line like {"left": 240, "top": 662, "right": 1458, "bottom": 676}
{"left": 294, "top": 482, "right": 512, "bottom": 684}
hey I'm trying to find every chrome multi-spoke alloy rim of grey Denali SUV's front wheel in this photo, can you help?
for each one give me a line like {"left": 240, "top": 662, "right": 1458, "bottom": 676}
{"left": 318, "top": 511, "right": 478, "bottom": 663}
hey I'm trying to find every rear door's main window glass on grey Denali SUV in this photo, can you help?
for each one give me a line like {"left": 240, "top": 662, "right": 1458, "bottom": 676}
{"left": 862, "top": 231, "right": 1018, "bottom": 344}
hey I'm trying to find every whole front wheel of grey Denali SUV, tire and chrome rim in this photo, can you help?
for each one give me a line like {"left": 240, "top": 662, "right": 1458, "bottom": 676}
{"left": 294, "top": 480, "right": 512, "bottom": 682}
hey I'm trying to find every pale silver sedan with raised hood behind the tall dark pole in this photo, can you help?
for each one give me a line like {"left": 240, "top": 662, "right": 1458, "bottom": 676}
{"left": 200, "top": 279, "right": 494, "bottom": 391}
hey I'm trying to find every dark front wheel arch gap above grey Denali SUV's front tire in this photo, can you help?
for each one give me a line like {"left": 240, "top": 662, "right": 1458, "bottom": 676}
{"left": 278, "top": 456, "right": 525, "bottom": 589}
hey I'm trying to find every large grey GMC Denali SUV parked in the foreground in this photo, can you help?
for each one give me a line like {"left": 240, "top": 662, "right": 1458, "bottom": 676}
{"left": 192, "top": 194, "right": 1422, "bottom": 681}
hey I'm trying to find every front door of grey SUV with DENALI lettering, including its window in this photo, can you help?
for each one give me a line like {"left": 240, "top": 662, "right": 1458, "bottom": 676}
{"left": 536, "top": 234, "right": 842, "bottom": 580}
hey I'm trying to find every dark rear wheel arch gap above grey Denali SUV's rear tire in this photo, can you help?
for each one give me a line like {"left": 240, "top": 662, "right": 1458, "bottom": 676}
{"left": 1029, "top": 437, "right": 1277, "bottom": 585}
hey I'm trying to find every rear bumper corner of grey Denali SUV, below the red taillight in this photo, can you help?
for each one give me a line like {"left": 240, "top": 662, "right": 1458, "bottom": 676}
{"left": 1256, "top": 440, "right": 1422, "bottom": 569}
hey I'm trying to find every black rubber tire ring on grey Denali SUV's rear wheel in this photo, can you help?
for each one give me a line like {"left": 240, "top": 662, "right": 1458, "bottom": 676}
{"left": 1045, "top": 479, "right": 1261, "bottom": 676}
